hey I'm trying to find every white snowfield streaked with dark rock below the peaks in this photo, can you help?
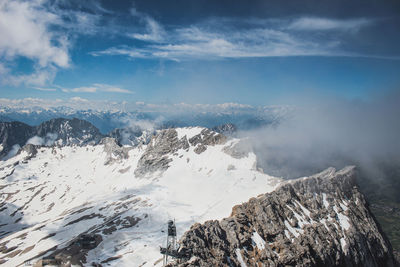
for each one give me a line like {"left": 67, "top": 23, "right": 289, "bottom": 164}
{"left": 0, "top": 128, "right": 280, "bottom": 266}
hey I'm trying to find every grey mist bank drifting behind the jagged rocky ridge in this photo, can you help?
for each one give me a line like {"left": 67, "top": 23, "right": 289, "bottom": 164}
{"left": 239, "top": 92, "right": 400, "bottom": 184}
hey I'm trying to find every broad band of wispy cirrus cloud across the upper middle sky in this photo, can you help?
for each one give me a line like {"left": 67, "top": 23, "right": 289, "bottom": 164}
{"left": 91, "top": 13, "right": 373, "bottom": 60}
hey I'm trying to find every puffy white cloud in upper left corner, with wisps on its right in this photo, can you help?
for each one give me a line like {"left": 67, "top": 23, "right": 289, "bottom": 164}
{"left": 0, "top": 0, "right": 108, "bottom": 87}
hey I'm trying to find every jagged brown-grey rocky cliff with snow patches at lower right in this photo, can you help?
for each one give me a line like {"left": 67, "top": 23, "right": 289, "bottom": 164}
{"left": 170, "top": 167, "right": 394, "bottom": 267}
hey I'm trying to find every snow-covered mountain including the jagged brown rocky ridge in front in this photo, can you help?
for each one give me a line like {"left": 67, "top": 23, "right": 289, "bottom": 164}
{"left": 0, "top": 121, "right": 392, "bottom": 266}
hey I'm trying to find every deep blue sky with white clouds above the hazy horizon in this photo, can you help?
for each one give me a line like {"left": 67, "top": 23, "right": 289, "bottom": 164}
{"left": 0, "top": 0, "right": 400, "bottom": 105}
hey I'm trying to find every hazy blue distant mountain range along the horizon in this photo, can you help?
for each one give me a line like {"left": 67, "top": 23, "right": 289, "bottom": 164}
{"left": 0, "top": 106, "right": 290, "bottom": 134}
